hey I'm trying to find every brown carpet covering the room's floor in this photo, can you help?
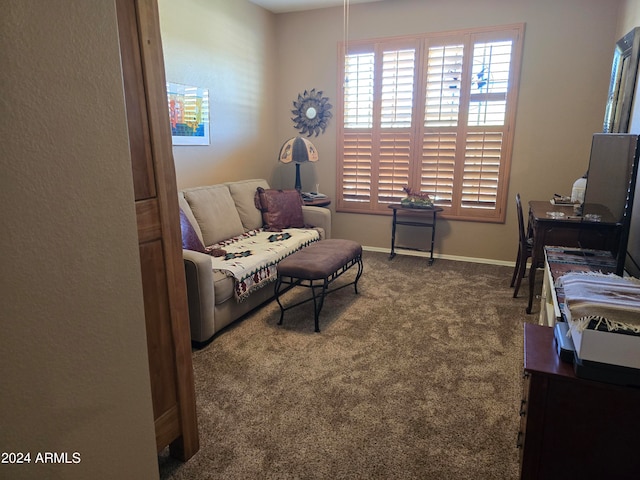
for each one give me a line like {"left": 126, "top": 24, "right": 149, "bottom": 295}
{"left": 159, "top": 252, "right": 537, "bottom": 480}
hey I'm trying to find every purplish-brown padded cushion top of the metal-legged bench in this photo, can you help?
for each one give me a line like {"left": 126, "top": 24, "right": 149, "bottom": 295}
{"left": 277, "top": 238, "right": 362, "bottom": 280}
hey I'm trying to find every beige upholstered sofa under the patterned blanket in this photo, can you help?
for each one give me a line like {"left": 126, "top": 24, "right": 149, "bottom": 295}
{"left": 178, "top": 179, "right": 331, "bottom": 344}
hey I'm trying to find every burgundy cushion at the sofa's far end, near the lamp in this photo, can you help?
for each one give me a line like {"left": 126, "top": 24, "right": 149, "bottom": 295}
{"left": 255, "top": 187, "right": 304, "bottom": 230}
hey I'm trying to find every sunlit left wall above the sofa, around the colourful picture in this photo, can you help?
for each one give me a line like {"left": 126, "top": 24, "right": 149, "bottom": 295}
{"left": 158, "top": 0, "right": 280, "bottom": 188}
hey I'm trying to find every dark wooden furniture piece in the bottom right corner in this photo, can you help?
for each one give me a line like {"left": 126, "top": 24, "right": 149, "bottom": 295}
{"left": 518, "top": 323, "right": 640, "bottom": 480}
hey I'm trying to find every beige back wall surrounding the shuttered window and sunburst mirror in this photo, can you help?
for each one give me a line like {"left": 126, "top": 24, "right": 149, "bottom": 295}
{"left": 277, "top": 0, "right": 617, "bottom": 261}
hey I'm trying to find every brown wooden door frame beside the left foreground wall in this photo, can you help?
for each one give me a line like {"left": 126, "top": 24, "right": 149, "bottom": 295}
{"left": 116, "top": 0, "right": 199, "bottom": 460}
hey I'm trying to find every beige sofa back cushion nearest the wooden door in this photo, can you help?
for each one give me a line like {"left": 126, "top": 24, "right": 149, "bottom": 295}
{"left": 183, "top": 185, "right": 244, "bottom": 246}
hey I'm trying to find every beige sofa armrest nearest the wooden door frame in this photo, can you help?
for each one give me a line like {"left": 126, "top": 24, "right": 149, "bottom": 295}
{"left": 182, "top": 250, "right": 215, "bottom": 342}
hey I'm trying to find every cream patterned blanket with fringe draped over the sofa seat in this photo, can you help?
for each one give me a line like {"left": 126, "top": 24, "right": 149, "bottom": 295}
{"left": 205, "top": 228, "right": 320, "bottom": 302}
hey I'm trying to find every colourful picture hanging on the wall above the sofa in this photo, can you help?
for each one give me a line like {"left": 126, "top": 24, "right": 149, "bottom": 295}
{"left": 167, "top": 82, "right": 209, "bottom": 145}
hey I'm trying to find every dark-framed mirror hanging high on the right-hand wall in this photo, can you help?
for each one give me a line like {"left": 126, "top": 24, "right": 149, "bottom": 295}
{"left": 602, "top": 27, "right": 640, "bottom": 133}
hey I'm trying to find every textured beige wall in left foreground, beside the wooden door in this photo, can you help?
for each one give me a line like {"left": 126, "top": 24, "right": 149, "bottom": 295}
{"left": 0, "top": 0, "right": 158, "bottom": 479}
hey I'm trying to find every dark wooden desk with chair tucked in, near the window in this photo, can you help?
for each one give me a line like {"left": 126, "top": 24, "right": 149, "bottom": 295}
{"left": 527, "top": 200, "right": 620, "bottom": 313}
